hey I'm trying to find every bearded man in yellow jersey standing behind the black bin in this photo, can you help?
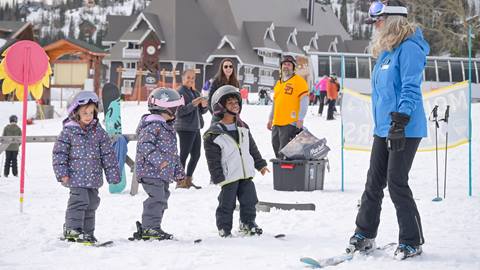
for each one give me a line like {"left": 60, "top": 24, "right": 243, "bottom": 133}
{"left": 267, "top": 55, "right": 308, "bottom": 158}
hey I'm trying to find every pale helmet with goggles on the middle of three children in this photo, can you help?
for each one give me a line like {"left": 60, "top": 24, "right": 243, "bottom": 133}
{"left": 148, "top": 87, "right": 185, "bottom": 116}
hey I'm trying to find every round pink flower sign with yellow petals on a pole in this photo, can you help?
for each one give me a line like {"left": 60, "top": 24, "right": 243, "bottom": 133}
{"left": 0, "top": 40, "right": 52, "bottom": 101}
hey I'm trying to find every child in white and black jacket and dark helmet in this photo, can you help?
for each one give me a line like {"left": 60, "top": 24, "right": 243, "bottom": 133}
{"left": 204, "top": 85, "right": 269, "bottom": 237}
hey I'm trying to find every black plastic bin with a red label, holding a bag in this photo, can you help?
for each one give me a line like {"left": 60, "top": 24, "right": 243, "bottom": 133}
{"left": 270, "top": 159, "right": 328, "bottom": 191}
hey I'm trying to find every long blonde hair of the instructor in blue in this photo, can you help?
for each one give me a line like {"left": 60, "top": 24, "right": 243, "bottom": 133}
{"left": 370, "top": 16, "right": 416, "bottom": 58}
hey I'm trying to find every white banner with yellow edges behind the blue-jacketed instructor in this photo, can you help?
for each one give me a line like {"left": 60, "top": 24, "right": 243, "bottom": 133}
{"left": 341, "top": 81, "right": 469, "bottom": 151}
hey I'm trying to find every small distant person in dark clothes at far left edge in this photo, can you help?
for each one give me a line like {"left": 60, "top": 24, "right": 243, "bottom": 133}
{"left": 2, "top": 115, "right": 22, "bottom": 177}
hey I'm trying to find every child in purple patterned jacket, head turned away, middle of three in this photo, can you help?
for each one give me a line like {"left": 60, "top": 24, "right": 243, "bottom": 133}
{"left": 132, "top": 88, "right": 185, "bottom": 240}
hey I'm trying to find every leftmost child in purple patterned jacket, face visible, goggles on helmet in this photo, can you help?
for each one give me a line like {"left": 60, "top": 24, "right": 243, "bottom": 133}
{"left": 53, "top": 91, "right": 120, "bottom": 244}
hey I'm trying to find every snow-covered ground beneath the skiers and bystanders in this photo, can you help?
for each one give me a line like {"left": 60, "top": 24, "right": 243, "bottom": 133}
{"left": 0, "top": 102, "right": 480, "bottom": 270}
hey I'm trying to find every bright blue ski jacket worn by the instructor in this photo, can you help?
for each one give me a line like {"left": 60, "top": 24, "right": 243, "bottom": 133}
{"left": 372, "top": 28, "right": 430, "bottom": 138}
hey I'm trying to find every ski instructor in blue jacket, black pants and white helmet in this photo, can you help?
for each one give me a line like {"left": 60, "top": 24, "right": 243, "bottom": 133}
{"left": 347, "top": 0, "right": 430, "bottom": 260}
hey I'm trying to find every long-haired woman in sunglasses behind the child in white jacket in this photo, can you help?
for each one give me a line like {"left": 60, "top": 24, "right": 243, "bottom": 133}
{"left": 208, "top": 58, "right": 240, "bottom": 123}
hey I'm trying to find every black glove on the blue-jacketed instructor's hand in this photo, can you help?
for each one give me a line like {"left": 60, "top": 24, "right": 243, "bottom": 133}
{"left": 387, "top": 112, "right": 410, "bottom": 152}
